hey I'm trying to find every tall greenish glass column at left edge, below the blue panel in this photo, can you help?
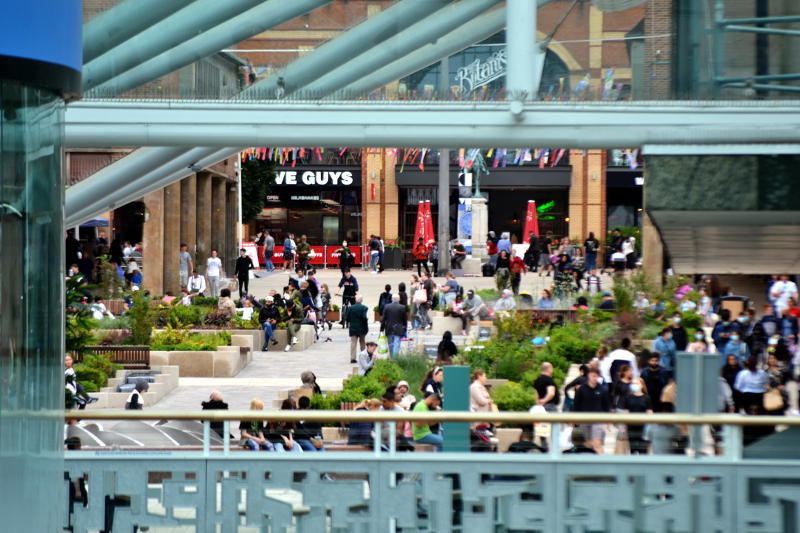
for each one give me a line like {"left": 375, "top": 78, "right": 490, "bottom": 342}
{"left": 0, "top": 81, "right": 65, "bottom": 531}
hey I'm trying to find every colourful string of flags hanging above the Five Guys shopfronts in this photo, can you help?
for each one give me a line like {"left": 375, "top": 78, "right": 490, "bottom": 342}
{"left": 242, "top": 147, "right": 639, "bottom": 169}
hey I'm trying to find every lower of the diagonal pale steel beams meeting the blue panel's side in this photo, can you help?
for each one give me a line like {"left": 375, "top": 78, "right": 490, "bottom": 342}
{"left": 83, "top": 0, "right": 262, "bottom": 91}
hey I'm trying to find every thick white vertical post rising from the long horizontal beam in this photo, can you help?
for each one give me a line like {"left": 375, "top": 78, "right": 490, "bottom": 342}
{"left": 506, "top": 0, "right": 537, "bottom": 102}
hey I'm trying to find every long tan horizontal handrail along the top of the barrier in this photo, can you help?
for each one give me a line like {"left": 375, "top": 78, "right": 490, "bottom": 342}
{"left": 64, "top": 409, "right": 800, "bottom": 426}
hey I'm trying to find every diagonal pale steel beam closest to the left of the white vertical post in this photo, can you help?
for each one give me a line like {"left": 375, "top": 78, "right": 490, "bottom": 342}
{"left": 298, "top": 0, "right": 500, "bottom": 98}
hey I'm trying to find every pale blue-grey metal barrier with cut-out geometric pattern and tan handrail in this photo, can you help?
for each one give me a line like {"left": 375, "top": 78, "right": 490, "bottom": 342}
{"left": 64, "top": 410, "right": 800, "bottom": 533}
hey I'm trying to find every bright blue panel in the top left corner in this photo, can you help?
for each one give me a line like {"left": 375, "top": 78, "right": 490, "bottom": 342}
{"left": 0, "top": 0, "right": 82, "bottom": 71}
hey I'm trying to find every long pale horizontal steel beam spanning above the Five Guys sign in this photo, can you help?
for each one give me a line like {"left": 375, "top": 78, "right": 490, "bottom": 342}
{"left": 66, "top": 101, "right": 800, "bottom": 148}
